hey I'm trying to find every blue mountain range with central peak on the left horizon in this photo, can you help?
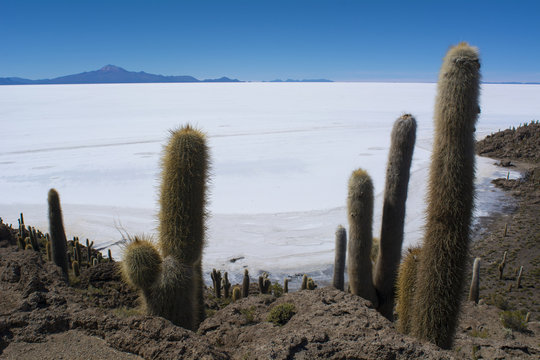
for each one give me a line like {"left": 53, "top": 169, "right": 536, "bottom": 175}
{"left": 0, "top": 65, "right": 241, "bottom": 85}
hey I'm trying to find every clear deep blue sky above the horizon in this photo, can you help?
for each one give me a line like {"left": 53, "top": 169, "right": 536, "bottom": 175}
{"left": 0, "top": 0, "right": 540, "bottom": 82}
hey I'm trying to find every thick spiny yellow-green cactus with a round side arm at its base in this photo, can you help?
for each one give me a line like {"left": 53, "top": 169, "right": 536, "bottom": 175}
{"left": 122, "top": 125, "right": 209, "bottom": 329}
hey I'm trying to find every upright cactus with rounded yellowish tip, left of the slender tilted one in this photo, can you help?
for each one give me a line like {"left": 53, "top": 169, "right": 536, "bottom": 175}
{"left": 347, "top": 169, "right": 377, "bottom": 307}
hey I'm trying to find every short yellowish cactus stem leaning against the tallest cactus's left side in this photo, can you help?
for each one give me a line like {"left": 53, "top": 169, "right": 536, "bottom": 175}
{"left": 396, "top": 247, "right": 420, "bottom": 334}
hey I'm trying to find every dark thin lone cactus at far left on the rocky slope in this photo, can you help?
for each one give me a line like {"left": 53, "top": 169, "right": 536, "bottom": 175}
{"left": 47, "top": 189, "right": 69, "bottom": 279}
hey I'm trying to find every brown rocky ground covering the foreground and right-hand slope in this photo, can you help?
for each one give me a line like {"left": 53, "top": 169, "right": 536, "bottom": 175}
{"left": 0, "top": 124, "right": 540, "bottom": 359}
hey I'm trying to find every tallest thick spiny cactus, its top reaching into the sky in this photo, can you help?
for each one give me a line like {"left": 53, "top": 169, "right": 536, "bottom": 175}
{"left": 412, "top": 43, "right": 480, "bottom": 349}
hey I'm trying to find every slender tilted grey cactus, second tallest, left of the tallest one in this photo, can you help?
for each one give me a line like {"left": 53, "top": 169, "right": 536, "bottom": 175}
{"left": 373, "top": 114, "right": 416, "bottom": 320}
